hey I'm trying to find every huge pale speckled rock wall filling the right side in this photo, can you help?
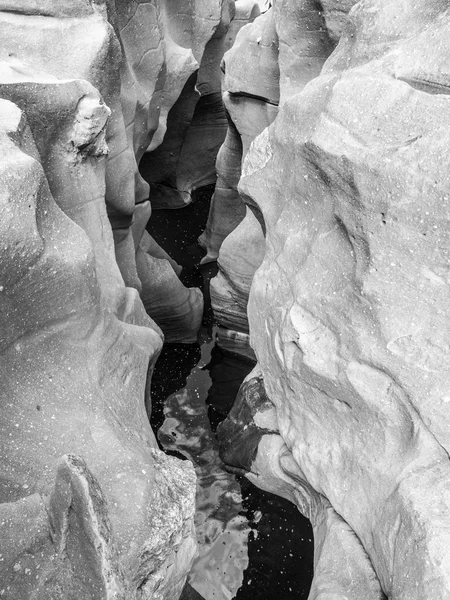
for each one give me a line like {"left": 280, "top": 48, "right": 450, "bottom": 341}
{"left": 221, "top": 0, "right": 450, "bottom": 600}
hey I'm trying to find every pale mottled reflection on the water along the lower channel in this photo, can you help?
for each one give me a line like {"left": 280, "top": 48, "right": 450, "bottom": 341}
{"left": 153, "top": 332, "right": 250, "bottom": 600}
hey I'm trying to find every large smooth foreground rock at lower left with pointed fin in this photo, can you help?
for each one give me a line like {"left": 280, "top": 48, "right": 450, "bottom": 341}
{"left": 0, "top": 101, "right": 195, "bottom": 600}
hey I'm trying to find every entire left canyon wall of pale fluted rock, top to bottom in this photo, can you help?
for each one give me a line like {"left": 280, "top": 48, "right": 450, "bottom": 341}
{"left": 0, "top": 0, "right": 252, "bottom": 600}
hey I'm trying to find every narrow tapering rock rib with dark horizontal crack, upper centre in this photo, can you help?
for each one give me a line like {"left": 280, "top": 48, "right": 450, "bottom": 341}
{"left": 199, "top": 10, "right": 279, "bottom": 264}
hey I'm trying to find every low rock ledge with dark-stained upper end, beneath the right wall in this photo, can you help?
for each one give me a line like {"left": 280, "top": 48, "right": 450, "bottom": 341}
{"left": 218, "top": 366, "right": 383, "bottom": 600}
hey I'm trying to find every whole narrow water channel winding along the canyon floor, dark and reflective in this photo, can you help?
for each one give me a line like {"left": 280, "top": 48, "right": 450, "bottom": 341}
{"left": 149, "top": 188, "right": 313, "bottom": 600}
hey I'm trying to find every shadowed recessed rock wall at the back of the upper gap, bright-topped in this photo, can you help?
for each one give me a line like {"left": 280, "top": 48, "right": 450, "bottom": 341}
{"left": 141, "top": 0, "right": 255, "bottom": 208}
